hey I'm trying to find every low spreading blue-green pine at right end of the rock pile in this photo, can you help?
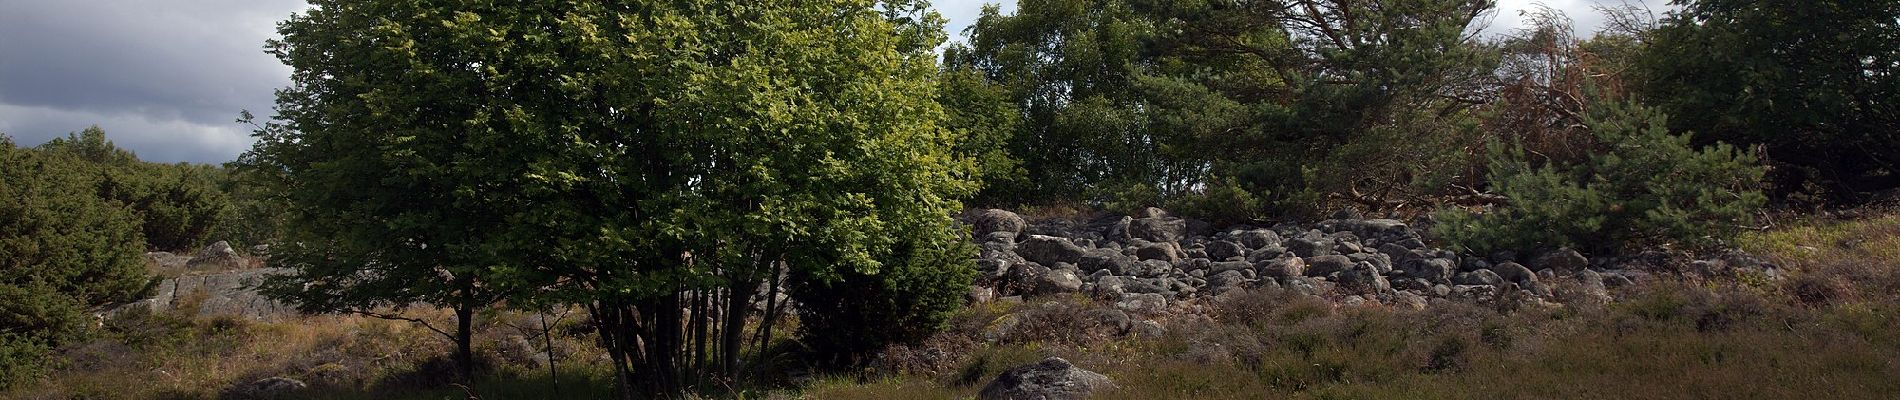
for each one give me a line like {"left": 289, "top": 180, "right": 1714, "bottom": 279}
{"left": 1435, "top": 102, "right": 1765, "bottom": 254}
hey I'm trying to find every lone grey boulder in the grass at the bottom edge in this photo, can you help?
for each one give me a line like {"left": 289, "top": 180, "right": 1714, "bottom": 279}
{"left": 977, "top": 356, "right": 1115, "bottom": 400}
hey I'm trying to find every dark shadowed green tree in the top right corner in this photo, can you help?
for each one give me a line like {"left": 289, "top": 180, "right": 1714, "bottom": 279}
{"left": 1638, "top": 0, "right": 1900, "bottom": 203}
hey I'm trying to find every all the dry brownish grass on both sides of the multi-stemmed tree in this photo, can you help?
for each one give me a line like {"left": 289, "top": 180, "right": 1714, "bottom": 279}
{"left": 18, "top": 214, "right": 1900, "bottom": 400}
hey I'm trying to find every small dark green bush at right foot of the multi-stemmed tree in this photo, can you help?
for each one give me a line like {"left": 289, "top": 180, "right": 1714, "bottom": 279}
{"left": 792, "top": 219, "right": 977, "bottom": 364}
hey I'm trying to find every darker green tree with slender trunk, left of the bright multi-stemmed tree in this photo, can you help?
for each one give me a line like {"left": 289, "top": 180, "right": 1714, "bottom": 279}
{"left": 236, "top": 0, "right": 532, "bottom": 379}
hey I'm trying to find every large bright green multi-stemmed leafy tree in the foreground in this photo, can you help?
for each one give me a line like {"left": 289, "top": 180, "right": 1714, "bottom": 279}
{"left": 473, "top": 2, "right": 973, "bottom": 392}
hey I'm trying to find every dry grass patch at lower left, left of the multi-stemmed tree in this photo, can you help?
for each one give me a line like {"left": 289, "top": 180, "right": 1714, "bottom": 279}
{"left": 0, "top": 305, "right": 612, "bottom": 398}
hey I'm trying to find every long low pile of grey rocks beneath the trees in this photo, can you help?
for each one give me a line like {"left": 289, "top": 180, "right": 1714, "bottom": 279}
{"left": 965, "top": 209, "right": 1679, "bottom": 313}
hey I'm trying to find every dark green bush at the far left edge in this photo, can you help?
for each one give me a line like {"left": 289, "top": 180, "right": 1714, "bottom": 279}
{"left": 0, "top": 135, "right": 148, "bottom": 387}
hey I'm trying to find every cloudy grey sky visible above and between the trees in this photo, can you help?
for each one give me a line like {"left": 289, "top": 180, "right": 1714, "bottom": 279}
{"left": 0, "top": 0, "right": 1663, "bottom": 163}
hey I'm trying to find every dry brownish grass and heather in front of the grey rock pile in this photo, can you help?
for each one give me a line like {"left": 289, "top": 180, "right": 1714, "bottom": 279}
{"left": 798, "top": 214, "right": 1900, "bottom": 400}
